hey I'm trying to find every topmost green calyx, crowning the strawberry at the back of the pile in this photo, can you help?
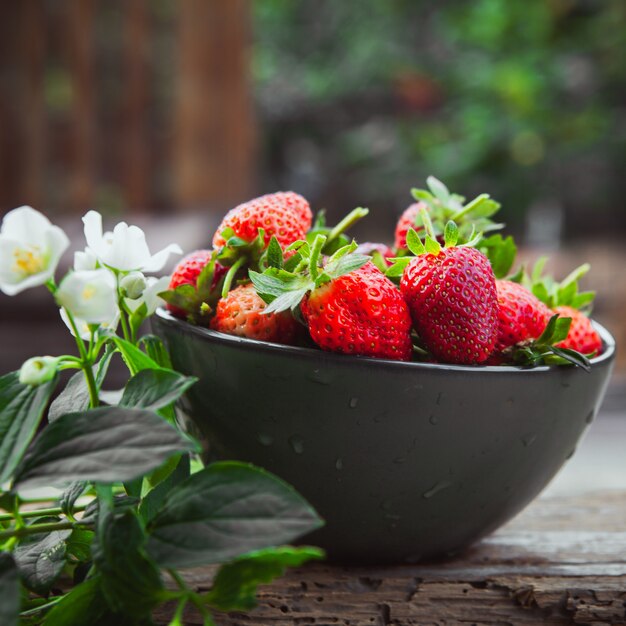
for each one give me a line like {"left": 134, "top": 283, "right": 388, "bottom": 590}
{"left": 407, "top": 176, "right": 504, "bottom": 243}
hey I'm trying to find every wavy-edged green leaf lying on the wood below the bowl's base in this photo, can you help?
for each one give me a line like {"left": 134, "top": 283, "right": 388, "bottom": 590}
{"left": 205, "top": 546, "right": 324, "bottom": 611}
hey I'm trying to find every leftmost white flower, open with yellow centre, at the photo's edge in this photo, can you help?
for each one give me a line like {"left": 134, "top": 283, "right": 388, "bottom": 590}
{"left": 0, "top": 206, "right": 70, "bottom": 296}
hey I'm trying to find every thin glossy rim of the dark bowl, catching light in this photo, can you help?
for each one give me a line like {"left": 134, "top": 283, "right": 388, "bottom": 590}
{"left": 155, "top": 307, "right": 615, "bottom": 375}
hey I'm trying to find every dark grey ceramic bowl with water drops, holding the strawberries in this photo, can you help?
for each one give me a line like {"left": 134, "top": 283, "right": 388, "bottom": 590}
{"left": 153, "top": 311, "right": 615, "bottom": 563}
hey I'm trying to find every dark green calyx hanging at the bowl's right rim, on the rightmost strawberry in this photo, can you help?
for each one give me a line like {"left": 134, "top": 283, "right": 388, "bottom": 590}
{"left": 505, "top": 314, "right": 591, "bottom": 372}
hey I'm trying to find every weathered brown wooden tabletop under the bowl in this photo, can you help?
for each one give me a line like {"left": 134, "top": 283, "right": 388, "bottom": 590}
{"left": 156, "top": 490, "right": 626, "bottom": 626}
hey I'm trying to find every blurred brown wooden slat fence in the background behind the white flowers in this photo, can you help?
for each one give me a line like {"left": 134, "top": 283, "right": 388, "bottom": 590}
{"left": 0, "top": 0, "right": 254, "bottom": 212}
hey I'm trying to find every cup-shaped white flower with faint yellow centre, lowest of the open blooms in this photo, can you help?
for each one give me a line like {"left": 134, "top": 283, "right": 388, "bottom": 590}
{"left": 56, "top": 269, "right": 118, "bottom": 324}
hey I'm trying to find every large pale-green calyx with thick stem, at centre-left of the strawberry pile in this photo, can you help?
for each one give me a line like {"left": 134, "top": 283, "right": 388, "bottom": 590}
{"left": 249, "top": 234, "right": 370, "bottom": 314}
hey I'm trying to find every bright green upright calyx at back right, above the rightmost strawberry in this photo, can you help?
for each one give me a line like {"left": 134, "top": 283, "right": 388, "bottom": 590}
{"left": 520, "top": 257, "right": 596, "bottom": 312}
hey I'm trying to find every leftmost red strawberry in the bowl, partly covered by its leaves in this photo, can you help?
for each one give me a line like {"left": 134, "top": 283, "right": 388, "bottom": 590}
{"left": 166, "top": 250, "right": 226, "bottom": 318}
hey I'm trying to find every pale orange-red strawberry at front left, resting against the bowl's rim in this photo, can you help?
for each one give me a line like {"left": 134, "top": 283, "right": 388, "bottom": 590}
{"left": 211, "top": 283, "right": 298, "bottom": 344}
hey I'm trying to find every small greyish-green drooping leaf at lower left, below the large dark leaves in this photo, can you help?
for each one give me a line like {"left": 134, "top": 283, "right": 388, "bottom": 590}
{"left": 14, "top": 530, "right": 72, "bottom": 595}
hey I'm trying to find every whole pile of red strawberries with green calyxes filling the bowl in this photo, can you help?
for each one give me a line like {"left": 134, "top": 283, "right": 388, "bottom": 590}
{"left": 161, "top": 177, "right": 602, "bottom": 368}
